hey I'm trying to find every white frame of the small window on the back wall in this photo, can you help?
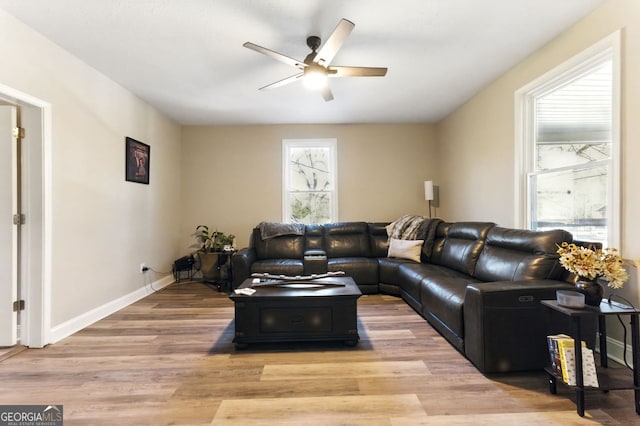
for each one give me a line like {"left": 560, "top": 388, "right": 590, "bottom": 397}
{"left": 282, "top": 139, "right": 338, "bottom": 223}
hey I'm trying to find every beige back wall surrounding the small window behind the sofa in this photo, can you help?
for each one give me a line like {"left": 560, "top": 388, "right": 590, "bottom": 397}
{"left": 182, "top": 124, "right": 438, "bottom": 248}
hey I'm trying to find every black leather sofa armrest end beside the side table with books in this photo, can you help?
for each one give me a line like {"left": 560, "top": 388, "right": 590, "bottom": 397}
{"left": 463, "top": 280, "right": 580, "bottom": 373}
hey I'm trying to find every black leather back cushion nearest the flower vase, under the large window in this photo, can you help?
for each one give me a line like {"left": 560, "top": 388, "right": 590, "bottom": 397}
{"left": 475, "top": 227, "right": 573, "bottom": 281}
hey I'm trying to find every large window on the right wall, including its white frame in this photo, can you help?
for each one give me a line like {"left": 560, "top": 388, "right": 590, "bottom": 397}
{"left": 516, "top": 33, "right": 620, "bottom": 247}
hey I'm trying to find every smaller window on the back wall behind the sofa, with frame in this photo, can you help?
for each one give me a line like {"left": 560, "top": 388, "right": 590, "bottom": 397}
{"left": 282, "top": 139, "right": 338, "bottom": 224}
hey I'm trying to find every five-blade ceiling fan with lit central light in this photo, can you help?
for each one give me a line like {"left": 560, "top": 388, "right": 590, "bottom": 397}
{"left": 243, "top": 19, "right": 387, "bottom": 101}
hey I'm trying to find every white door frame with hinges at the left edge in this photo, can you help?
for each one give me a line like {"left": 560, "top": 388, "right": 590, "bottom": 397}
{"left": 0, "top": 84, "right": 53, "bottom": 348}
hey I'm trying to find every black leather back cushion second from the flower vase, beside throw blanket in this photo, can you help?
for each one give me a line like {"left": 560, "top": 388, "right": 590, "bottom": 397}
{"left": 429, "top": 222, "right": 495, "bottom": 275}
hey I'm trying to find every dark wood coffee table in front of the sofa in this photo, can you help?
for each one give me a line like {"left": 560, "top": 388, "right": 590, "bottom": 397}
{"left": 229, "top": 277, "right": 362, "bottom": 348}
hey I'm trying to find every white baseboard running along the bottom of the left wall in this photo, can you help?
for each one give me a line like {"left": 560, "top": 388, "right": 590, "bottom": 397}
{"left": 49, "top": 275, "right": 175, "bottom": 343}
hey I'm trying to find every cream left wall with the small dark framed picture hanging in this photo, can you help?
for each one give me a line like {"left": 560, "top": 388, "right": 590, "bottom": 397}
{"left": 0, "top": 10, "right": 181, "bottom": 327}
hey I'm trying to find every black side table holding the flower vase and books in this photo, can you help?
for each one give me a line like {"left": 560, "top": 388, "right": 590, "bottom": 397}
{"left": 540, "top": 300, "right": 640, "bottom": 416}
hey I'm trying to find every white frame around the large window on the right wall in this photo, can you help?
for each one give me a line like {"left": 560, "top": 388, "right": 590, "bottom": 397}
{"left": 514, "top": 31, "right": 621, "bottom": 247}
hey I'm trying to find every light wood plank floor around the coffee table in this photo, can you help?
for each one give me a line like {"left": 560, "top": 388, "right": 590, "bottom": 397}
{"left": 0, "top": 283, "right": 640, "bottom": 426}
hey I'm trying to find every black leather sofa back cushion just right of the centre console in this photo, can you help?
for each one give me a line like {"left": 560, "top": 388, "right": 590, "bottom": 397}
{"left": 323, "top": 222, "right": 371, "bottom": 258}
